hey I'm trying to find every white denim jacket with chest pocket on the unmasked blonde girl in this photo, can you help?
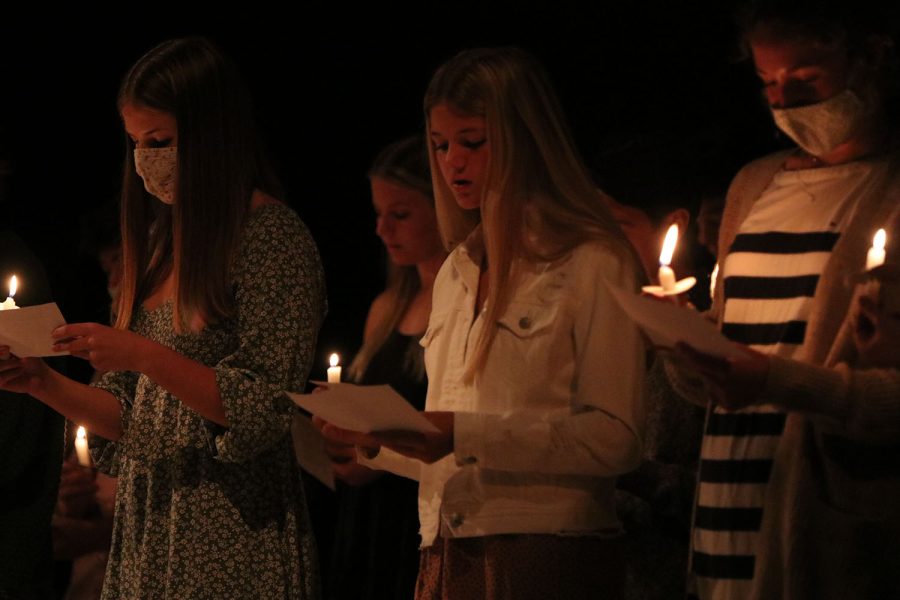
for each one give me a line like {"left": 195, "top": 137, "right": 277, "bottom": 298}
{"left": 364, "top": 233, "right": 645, "bottom": 547}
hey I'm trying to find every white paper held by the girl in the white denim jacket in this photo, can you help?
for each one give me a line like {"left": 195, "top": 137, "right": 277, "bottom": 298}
{"left": 287, "top": 383, "right": 438, "bottom": 433}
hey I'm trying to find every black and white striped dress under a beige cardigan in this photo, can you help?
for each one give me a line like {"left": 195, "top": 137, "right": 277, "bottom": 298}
{"left": 689, "top": 162, "right": 872, "bottom": 599}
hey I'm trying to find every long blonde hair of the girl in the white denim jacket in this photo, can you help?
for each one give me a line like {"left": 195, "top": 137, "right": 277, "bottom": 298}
{"left": 424, "top": 48, "right": 641, "bottom": 380}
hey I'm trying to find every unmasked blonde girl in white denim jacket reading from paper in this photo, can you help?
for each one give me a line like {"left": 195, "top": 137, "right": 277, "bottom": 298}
{"left": 323, "top": 48, "right": 645, "bottom": 598}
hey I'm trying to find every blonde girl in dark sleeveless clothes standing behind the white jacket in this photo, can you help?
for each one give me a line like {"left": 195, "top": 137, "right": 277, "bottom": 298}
{"left": 324, "top": 135, "right": 447, "bottom": 600}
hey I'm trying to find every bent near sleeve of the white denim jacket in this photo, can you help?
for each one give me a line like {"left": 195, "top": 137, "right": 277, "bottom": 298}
{"left": 454, "top": 246, "right": 645, "bottom": 476}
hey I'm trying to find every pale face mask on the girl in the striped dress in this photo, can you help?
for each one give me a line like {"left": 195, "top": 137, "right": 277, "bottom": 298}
{"left": 772, "top": 89, "right": 872, "bottom": 156}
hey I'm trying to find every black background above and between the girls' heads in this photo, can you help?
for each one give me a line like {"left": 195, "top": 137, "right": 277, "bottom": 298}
{"left": 0, "top": 0, "right": 776, "bottom": 378}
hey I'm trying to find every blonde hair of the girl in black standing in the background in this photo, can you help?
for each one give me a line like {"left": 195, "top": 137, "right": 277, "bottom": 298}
{"left": 348, "top": 135, "right": 434, "bottom": 381}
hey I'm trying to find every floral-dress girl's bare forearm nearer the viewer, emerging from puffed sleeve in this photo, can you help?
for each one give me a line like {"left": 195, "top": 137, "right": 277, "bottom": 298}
{"left": 138, "top": 342, "right": 228, "bottom": 427}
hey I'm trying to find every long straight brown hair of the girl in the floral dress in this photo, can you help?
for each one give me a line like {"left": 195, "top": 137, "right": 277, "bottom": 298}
{"left": 116, "top": 37, "right": 280, "bottom": 332}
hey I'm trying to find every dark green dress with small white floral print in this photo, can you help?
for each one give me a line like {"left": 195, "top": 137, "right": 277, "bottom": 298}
{"left": 91, "top": 204, "right": 326, "bottom": 599}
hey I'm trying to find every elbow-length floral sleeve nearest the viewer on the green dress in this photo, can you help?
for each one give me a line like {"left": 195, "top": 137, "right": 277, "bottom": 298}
{"left": 208, "top": 209, "right": 326, "bottom": 462}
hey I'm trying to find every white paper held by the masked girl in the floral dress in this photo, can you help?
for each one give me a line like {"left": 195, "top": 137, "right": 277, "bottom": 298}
{"left": 0, "top": 302, "right": 68, "bottom": 358}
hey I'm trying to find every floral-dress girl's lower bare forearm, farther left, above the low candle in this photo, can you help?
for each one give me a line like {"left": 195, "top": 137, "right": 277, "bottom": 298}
{"left": 34, "top": 370, "right": 122, "bottom": 441}
